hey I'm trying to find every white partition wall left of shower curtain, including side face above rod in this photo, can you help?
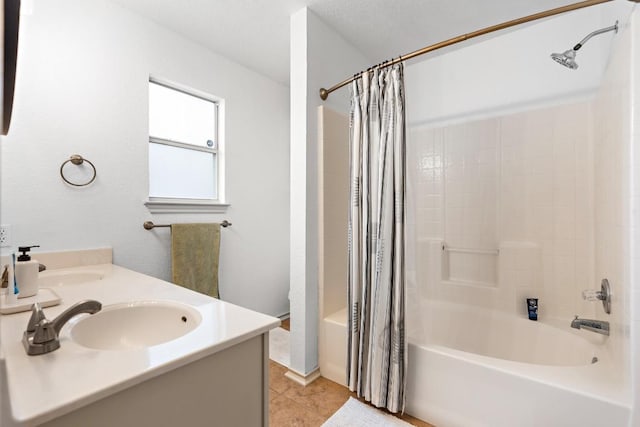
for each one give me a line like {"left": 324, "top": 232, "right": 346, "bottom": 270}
{"left": 290, "top": 8, "right": 370, "bottom": 375}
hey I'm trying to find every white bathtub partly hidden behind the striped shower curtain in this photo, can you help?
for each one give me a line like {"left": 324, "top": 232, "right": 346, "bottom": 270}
{"left": 320, "top": 303, "right": 630, "bottom": 427}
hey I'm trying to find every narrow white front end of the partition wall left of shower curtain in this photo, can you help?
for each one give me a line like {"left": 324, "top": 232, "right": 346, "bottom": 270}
{"left": 289, "top": 8, "right": 318, "bottom": 383}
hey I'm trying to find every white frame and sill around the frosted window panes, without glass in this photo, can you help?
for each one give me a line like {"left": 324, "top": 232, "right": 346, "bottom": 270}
{"left": 144, "top": 75, "right": 230, "bottom": 213}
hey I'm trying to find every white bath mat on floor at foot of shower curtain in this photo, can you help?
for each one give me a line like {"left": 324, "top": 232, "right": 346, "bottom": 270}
{"left": 322, "top": 397, "right": 411, "bottom": 427}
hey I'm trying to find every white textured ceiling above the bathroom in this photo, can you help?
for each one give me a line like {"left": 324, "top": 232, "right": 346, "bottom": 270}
{"left": 112, "top": 0, "right": 573, "bottom": 84}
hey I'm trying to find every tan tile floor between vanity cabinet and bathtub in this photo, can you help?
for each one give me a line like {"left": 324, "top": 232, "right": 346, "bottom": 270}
{"left": 269, "top": 361, "right": 433, "bottom": 427}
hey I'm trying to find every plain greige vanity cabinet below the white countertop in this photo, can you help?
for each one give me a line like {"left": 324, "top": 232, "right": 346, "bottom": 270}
{"left": 42, "top": 334, "right": 269, "bottom": 427}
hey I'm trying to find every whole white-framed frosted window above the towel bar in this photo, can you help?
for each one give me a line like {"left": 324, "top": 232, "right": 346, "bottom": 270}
{"left": 146, "top": 79, "right": 227, "bottom": 212}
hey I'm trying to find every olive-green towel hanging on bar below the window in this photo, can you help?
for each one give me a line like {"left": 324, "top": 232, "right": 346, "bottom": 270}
{"left": 171, "top": 224, "right": 220, "bottom": 298}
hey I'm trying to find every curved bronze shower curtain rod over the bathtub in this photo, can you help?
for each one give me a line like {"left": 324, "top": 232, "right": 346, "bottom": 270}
{"left": 320, "top": 0, "right": 628, "bottom": 101}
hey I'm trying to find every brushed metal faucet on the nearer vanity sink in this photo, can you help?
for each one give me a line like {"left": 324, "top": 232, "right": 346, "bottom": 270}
{"left": 22, "top": 300, "right": 102, "bottom": 356}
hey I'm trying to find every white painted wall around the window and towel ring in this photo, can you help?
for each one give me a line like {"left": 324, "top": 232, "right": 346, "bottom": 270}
{"left": 0, "top": 0, "right": 289, "bottom": 315}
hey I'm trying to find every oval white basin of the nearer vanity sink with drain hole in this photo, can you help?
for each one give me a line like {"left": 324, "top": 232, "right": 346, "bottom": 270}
{"left": 70, "top": 301, "right": 202, "bottom": 350}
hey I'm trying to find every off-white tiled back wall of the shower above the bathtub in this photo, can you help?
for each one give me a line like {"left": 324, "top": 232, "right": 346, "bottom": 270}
{"left": 407, "top": 101, "right": 597, "bottom": 318}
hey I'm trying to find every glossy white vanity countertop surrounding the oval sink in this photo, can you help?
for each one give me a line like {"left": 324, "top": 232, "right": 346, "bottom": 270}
{"left": 0, "top": 264, "right": 280, "bottom": 425}
